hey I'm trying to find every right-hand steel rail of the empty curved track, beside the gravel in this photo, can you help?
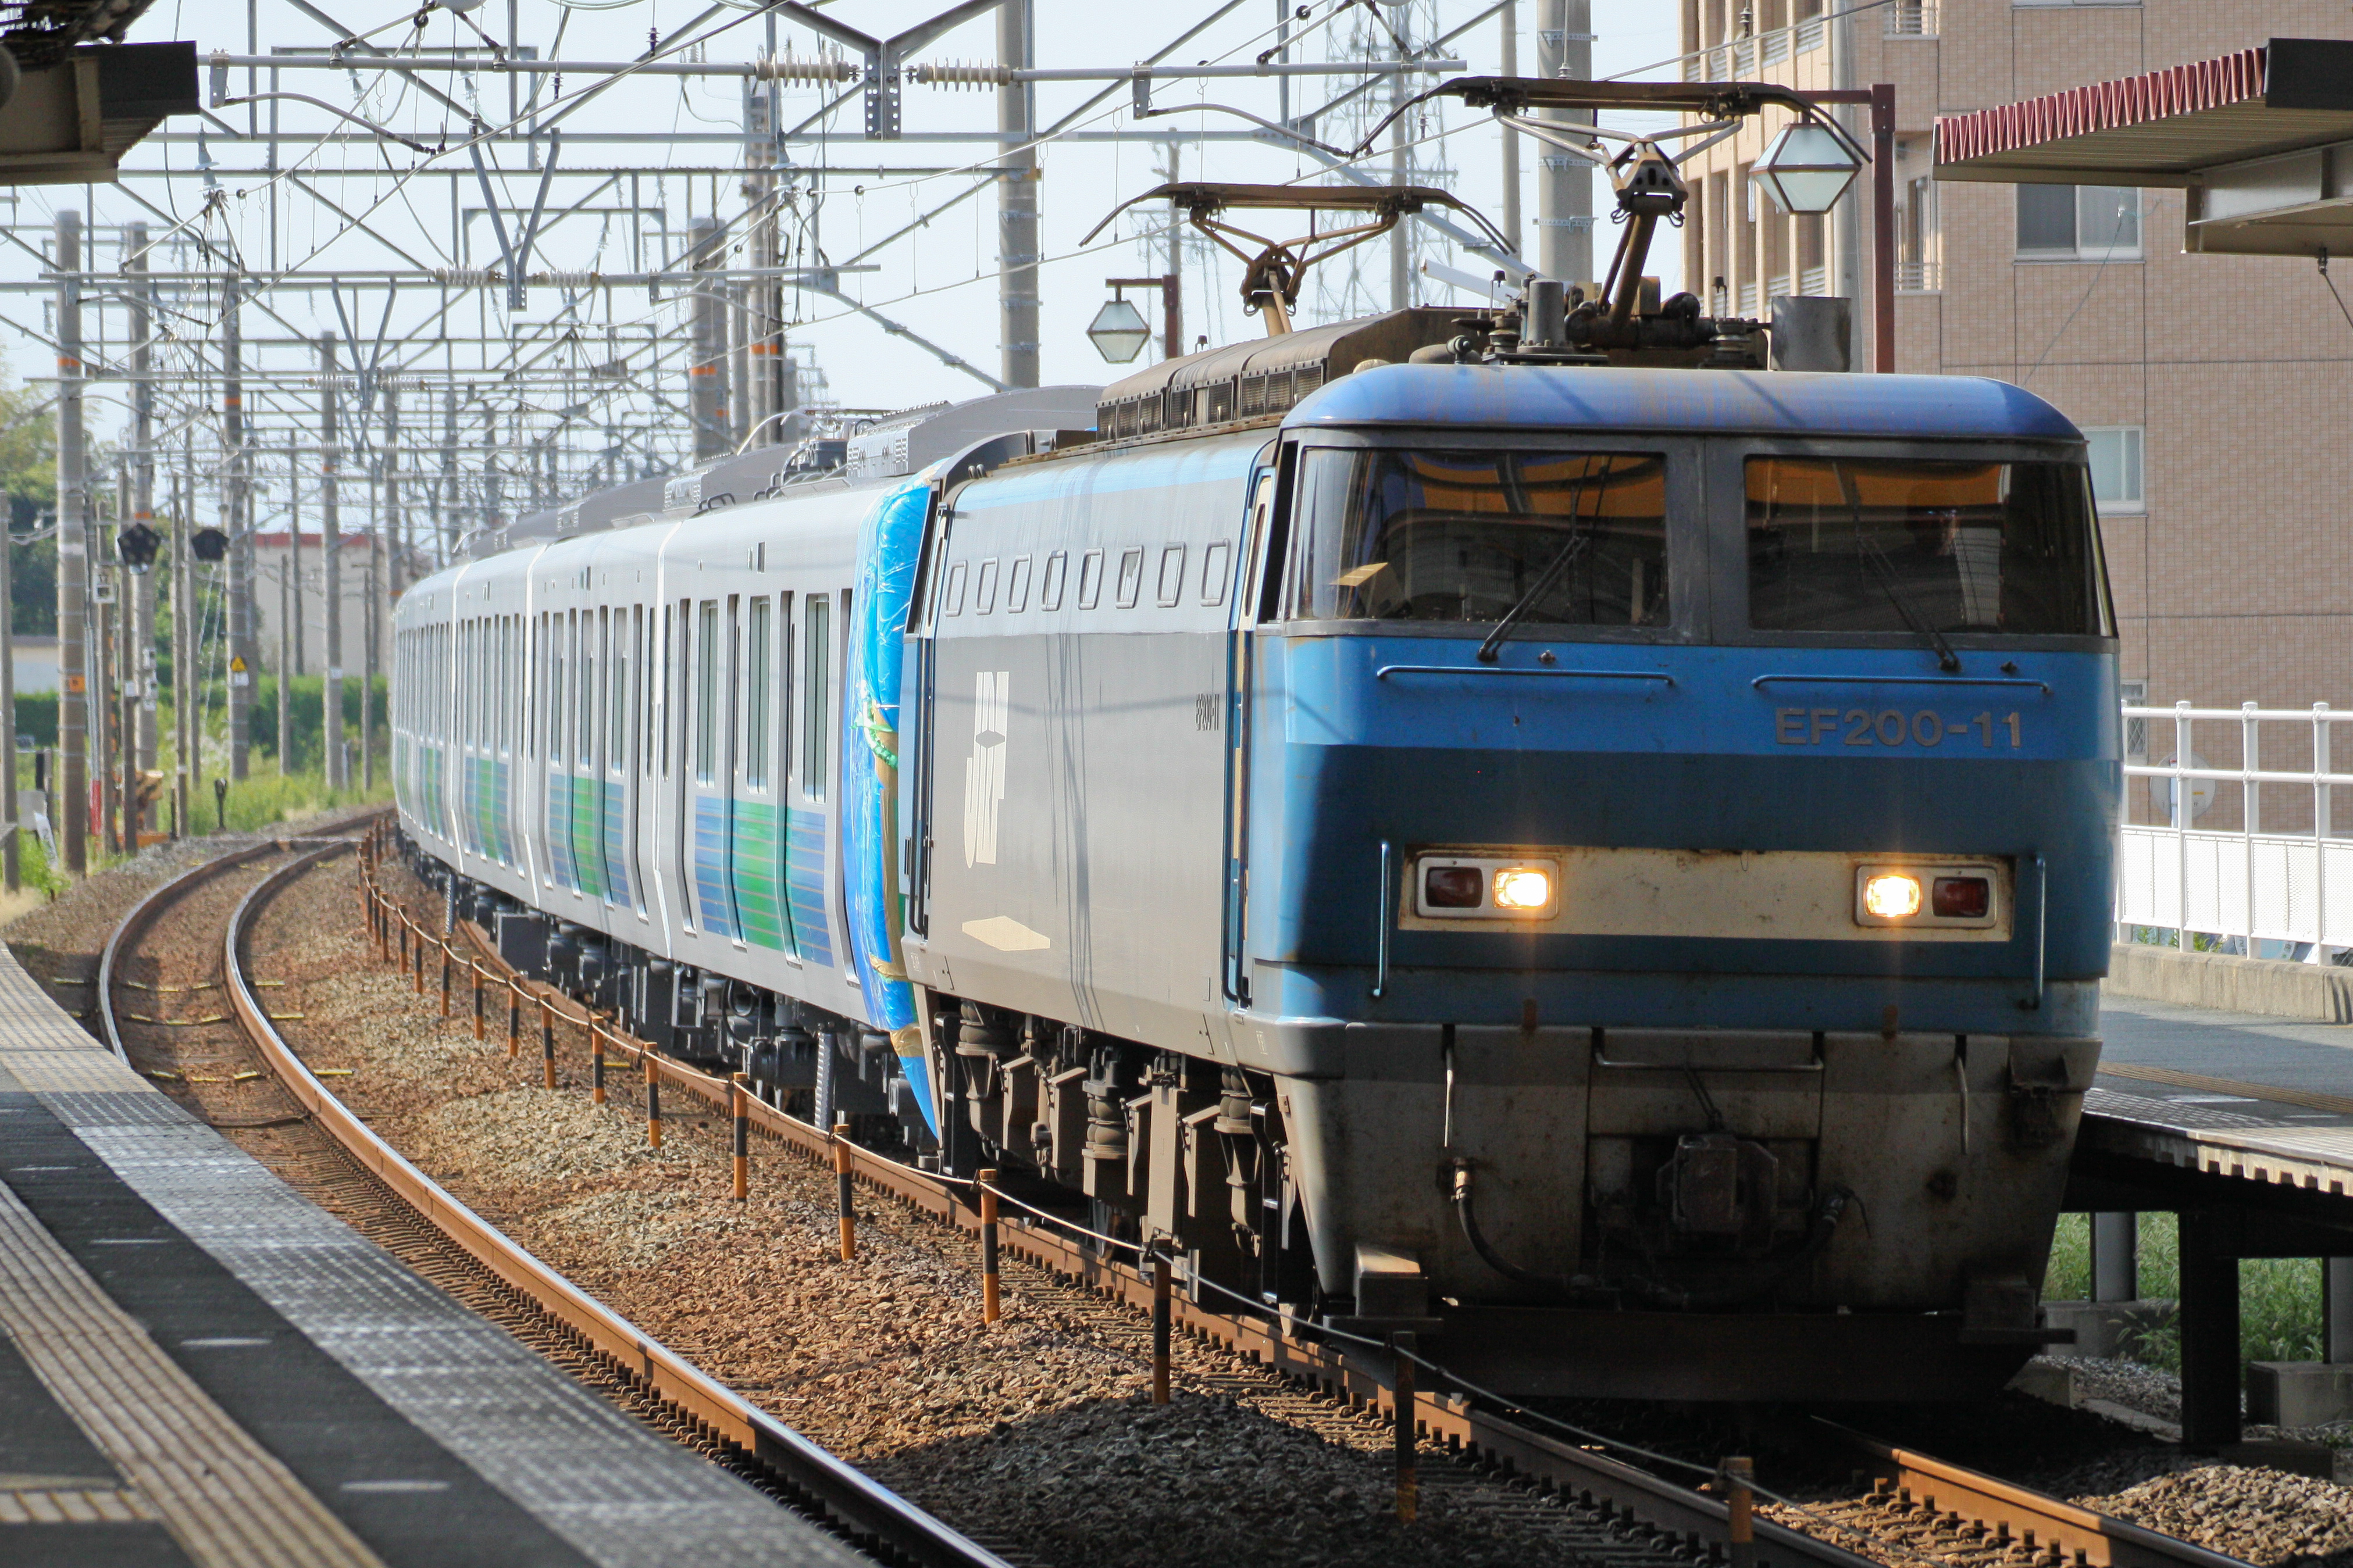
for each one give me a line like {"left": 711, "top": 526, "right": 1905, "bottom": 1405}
{"left": 219, "top": 840, "right": 1012, "bottom": 1568}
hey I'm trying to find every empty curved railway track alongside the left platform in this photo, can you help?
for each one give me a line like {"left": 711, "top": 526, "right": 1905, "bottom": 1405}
{"left": 97, "top": 837, "right": 1010, "bottom": 1568}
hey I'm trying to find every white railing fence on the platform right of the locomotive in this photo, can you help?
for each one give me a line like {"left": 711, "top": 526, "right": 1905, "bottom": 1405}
{"left": 2115, "top": 703, "right": 2353, "bottom": 959}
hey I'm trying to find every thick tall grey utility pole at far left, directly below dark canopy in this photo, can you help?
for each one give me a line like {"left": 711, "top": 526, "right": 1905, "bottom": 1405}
{"left": 55, "top": 207, "right": 90, "bottom": 877}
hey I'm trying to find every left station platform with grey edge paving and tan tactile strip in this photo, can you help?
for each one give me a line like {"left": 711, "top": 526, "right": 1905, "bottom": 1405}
{"left": 0, "top": 950, "right": 871, "bottom": 1568}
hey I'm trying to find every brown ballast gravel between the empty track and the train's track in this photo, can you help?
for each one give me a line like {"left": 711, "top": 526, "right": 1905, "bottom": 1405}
{"left": 256, "top": 863, "right": 1609, "bottom": 1568}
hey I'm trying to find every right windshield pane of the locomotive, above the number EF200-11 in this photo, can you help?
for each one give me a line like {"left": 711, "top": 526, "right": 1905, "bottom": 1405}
{"left": 1748, "top": 456, "right": 2108, "bottom": 637}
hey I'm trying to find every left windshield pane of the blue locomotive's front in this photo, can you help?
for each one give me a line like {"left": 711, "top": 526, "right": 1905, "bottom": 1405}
{"left": 1292, "top": 449, "right": 1669, "bottom": 626}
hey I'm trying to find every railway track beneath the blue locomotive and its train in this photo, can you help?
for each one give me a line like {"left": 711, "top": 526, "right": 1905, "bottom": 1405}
{"left": 343, "top": 841, "right": 2247, "bottom": 1568}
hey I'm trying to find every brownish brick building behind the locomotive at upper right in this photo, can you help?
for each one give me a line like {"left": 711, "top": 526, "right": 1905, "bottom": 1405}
{"left": 1682, "top": 0, "right": 2353, "bottom": 719}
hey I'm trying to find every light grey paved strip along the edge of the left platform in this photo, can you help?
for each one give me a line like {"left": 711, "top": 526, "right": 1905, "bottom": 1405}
{"left": 0, "top": 921, "right": 871, "bottom": 1568}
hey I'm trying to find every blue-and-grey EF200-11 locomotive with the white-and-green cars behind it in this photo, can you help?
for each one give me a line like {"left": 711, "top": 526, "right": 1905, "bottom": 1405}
{"left": 398, "top": 313, "right": 2117, "bottom": 1399}
